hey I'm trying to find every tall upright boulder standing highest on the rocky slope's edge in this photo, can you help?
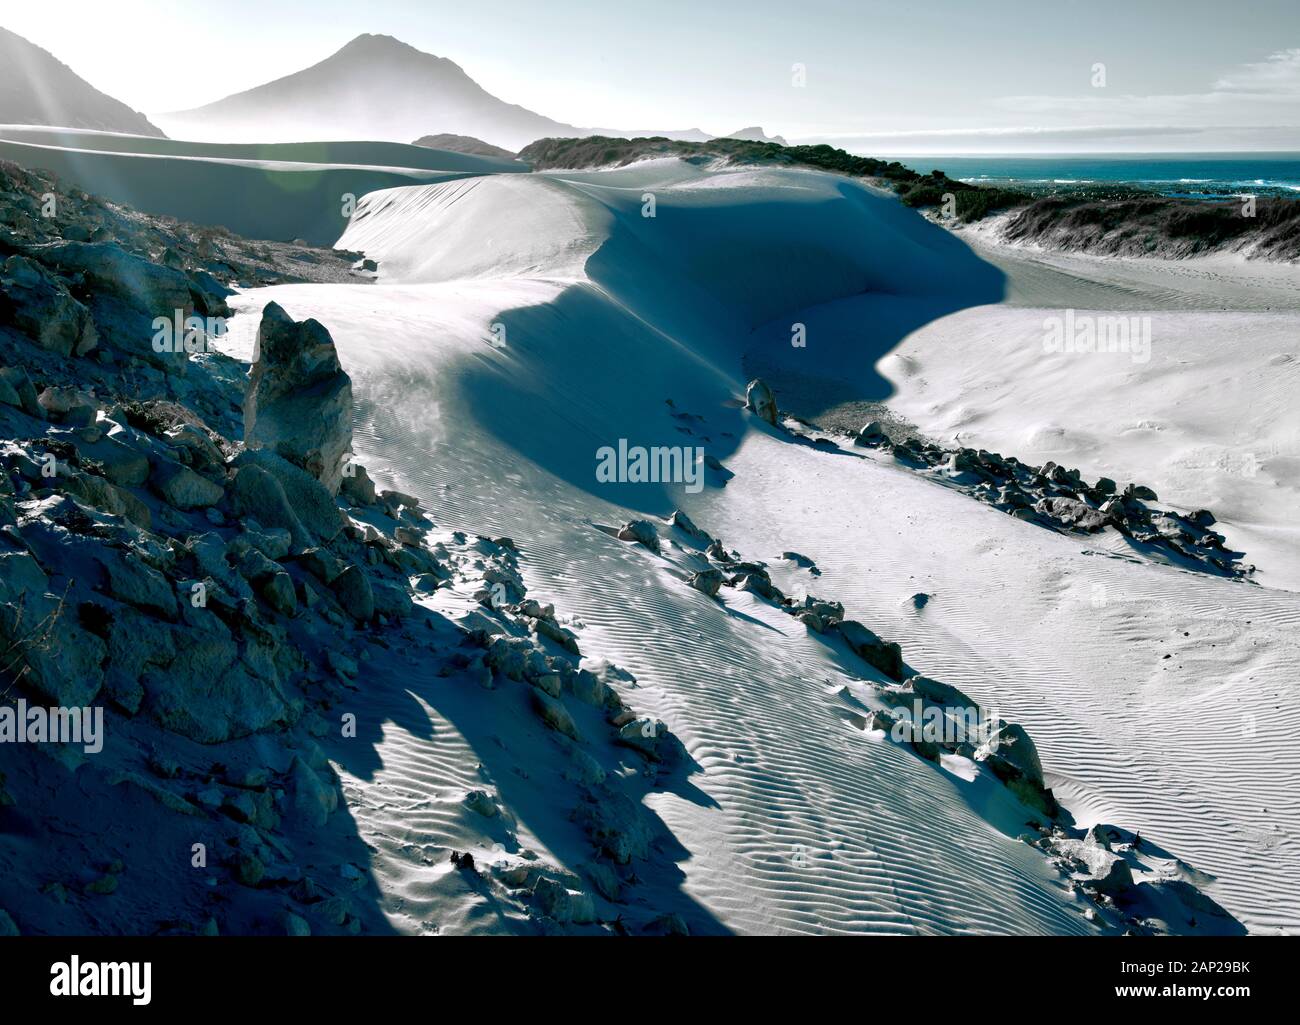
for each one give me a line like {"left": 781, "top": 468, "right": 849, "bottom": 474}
{"left": 244, "top": 303, "right": 352, "bottom": 496}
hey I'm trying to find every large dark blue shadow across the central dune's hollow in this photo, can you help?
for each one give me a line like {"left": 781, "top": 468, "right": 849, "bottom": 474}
{"left": 452, "top": 175, "right": 1006, "bottom": 515}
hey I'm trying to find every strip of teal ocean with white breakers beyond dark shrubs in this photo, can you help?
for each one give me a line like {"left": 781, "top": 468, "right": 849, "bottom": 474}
{"left": 896, "top": 153, "right": 1300, "bottom": 199}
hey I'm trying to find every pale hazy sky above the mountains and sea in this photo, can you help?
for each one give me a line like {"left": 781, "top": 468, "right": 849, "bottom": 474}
{"left": 0, "top": 0, "right": 1300, "bottom": 153}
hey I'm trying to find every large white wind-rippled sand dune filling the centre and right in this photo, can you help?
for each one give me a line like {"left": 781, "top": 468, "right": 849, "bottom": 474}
{"left": 208, "top": 161, "right": 1300, "bottom": 933}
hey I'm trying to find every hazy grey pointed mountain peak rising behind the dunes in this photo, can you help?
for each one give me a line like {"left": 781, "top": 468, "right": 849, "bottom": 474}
{"left": 157, "top": 35, "right": 577, "bottom": 151}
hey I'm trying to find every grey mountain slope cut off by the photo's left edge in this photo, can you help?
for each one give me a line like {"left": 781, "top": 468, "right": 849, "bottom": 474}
{"left": 0, "top": 29, "right": 163, "bottom": 137}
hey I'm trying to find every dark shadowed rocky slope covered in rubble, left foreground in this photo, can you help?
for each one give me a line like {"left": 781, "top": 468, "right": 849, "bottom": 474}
{"left": 0, "top": 158, "right": 733, "bottom": 935}
